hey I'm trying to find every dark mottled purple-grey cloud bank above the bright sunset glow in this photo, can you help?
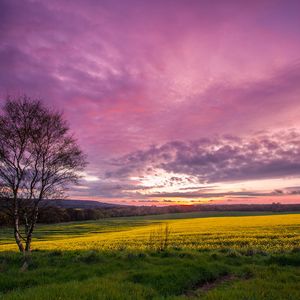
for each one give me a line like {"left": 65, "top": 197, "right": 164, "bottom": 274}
{"left": 110, "top": 131, "right": 300, "bottom": 184}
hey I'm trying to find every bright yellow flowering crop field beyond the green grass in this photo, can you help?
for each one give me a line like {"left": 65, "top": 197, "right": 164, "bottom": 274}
{"left": 0, "top": 213, "right": 300, "bottom": 252}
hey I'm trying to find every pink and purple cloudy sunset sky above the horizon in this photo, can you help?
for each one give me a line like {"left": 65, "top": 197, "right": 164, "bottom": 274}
{"left": 0, "top": 0, "right": 300, "bottom": 205}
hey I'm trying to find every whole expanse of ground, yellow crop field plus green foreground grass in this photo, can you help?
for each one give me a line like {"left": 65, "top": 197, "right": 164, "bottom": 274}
{"left": 0, "top": 213, "right": 300, "bottom": 300}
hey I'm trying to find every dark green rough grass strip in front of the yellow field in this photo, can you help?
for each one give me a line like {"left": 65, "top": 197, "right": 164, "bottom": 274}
{"left": 0, "top": 250, "right": 300, "bottom": 300}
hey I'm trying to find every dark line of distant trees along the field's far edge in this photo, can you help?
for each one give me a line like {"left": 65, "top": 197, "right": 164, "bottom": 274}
{"left": 0, "top": 201, "right": 300, "bottom": 226}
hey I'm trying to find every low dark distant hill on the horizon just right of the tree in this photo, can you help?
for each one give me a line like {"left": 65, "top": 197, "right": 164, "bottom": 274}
{"left": 43, "top": 199, "right": 123, "bottom": 209}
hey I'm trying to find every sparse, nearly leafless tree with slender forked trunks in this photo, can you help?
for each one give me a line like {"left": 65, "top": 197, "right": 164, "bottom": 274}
{"left": 0, "top": 96, "right": 86, "bottom": 257}
